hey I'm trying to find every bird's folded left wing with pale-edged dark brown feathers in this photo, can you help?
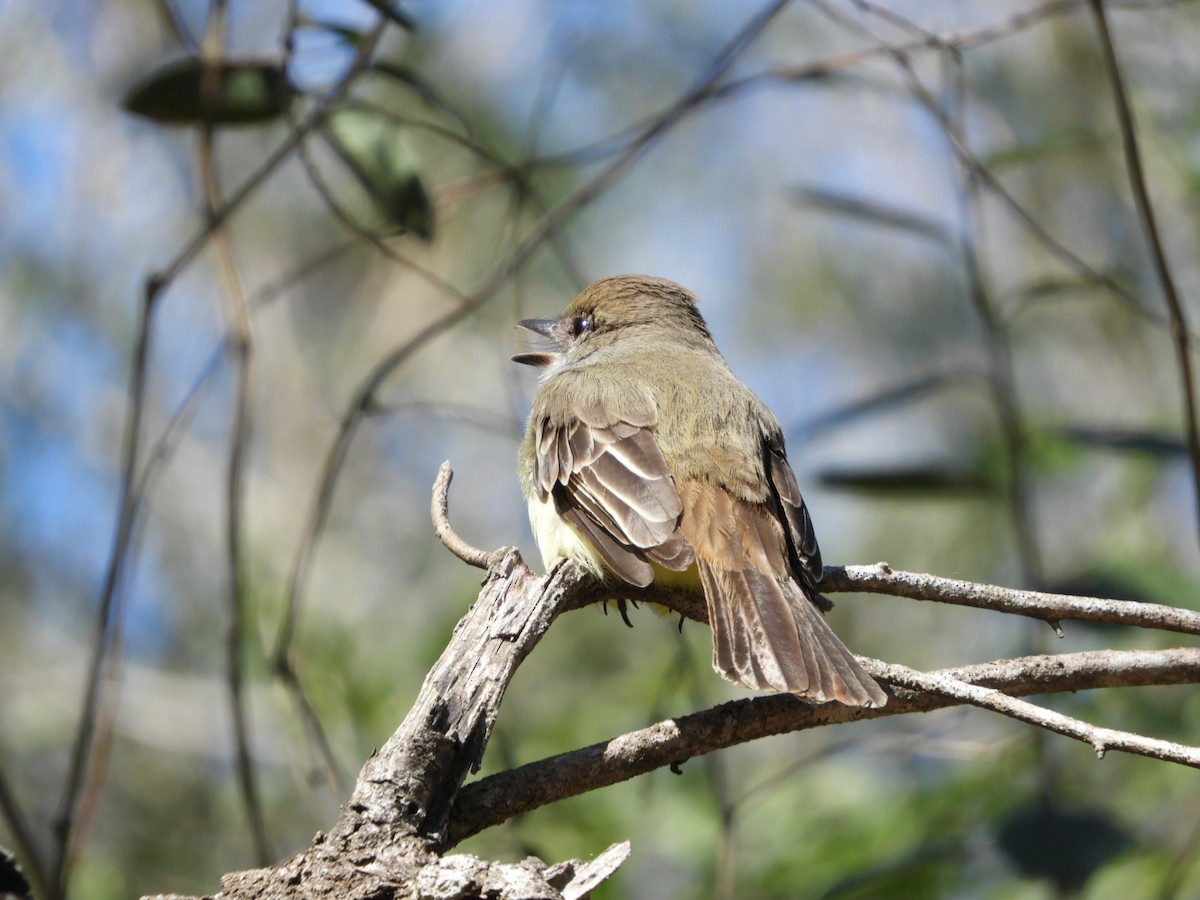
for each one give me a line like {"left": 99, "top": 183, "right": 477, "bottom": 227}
{"left": 534, "top": 401, "right": 692, "bottom": 587}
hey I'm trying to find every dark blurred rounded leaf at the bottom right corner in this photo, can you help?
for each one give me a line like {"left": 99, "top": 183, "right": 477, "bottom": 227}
{"left": 996, "top": 802, "right": 1133, "bottom": 892}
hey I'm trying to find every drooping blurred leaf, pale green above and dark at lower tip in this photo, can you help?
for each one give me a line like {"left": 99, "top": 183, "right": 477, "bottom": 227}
{"left": 325, "top": 108, "right": 433, "bottom": 240}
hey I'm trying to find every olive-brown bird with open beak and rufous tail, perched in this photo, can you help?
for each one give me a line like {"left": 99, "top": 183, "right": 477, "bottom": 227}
{"left": 512, "top": 275, "right": 887, "bottom": 707}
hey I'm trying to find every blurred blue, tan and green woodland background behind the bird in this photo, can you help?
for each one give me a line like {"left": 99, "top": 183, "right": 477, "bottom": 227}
{"left": 0, "top": 0, "right": 1200, "bottom": 900}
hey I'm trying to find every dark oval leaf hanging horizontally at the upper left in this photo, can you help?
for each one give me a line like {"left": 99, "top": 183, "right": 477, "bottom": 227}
{"left": 121, "top": 56, "right": 295, "bottom": 125}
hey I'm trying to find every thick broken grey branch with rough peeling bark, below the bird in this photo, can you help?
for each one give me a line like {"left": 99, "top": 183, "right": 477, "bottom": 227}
{"left": 175, "top": 548, "right": 604, "bottom": 900}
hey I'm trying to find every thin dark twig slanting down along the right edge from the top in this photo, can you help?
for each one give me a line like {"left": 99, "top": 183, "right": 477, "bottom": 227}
{"left": 1090, "top": 0, "right": 1200, "bottom": 556}
